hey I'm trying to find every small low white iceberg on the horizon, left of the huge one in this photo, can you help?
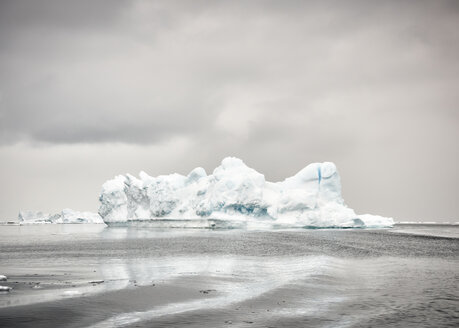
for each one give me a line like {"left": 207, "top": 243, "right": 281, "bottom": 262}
{"left": 18, "top": 208, "right": 104, "bottom": 224}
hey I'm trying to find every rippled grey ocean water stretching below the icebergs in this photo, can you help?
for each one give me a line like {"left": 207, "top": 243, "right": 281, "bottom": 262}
{"left": 0, "top": 225, "right": 459, "bottom": 327}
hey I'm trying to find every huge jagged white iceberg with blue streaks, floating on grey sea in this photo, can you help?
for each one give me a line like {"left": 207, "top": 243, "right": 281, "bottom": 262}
{"left": 99, "top": 157, "right": 394, "bottom": 228}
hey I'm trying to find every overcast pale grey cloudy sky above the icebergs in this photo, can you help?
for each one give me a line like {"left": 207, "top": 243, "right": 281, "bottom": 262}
{"left": 0, "top": 0, "right": 459, "bottom": 221}
